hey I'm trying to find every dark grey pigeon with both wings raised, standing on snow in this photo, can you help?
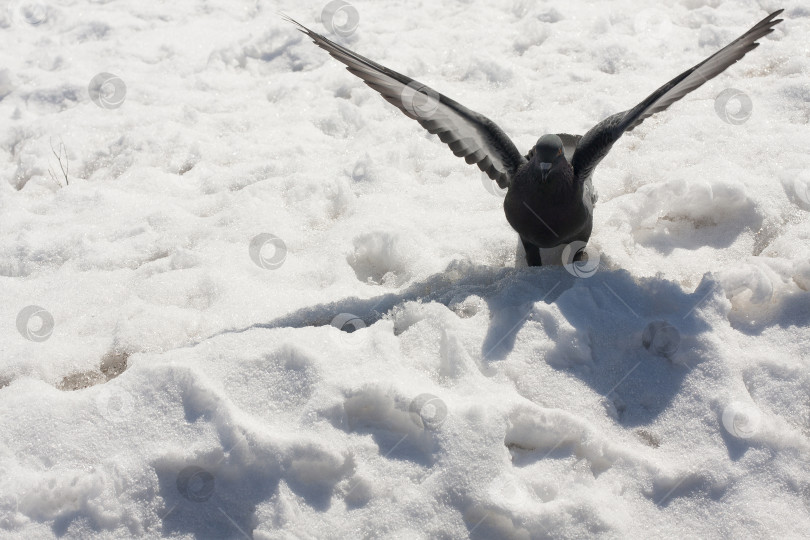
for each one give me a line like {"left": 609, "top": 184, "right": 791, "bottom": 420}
{"left": 282, "top": 9, "right": 783, "bottom": 266}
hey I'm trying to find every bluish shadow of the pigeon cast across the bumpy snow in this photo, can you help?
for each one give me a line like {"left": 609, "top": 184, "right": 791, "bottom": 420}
{"left": 202, "top": 255, "right": 722, "bottom": 426}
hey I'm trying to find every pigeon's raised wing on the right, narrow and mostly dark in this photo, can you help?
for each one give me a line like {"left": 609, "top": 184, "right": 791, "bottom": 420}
{"left": 571, "top": 9, "right": 783, "bottom": 178}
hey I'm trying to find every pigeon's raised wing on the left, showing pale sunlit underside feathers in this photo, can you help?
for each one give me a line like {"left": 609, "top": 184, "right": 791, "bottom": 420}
{"left": 284, "top": 16, "right": 526, "bottom": 188}
